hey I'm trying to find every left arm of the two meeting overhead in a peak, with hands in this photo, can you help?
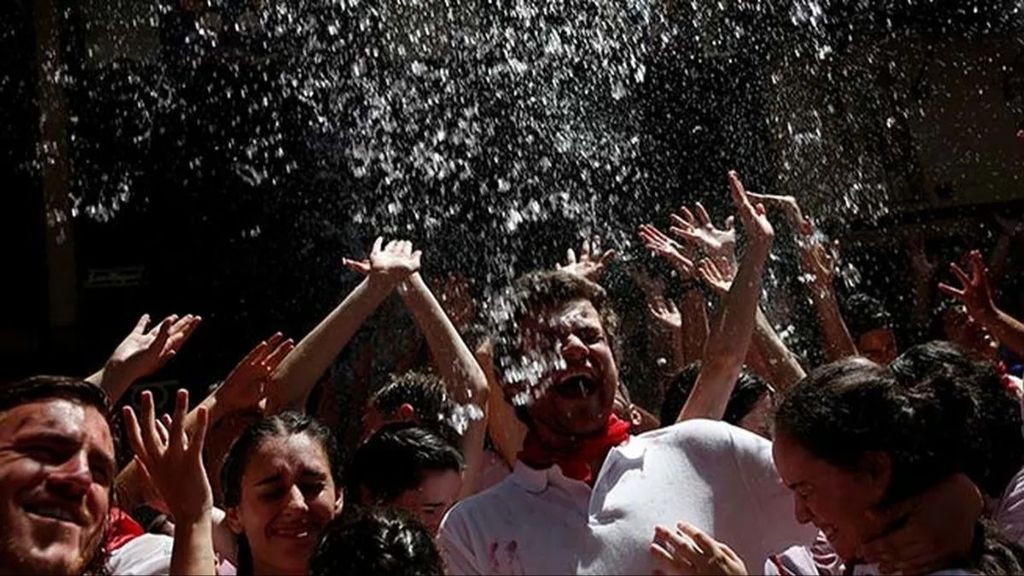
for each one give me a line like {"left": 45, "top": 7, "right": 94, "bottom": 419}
{"left": 267, "top": 238, "right": 420, "bottom": 413}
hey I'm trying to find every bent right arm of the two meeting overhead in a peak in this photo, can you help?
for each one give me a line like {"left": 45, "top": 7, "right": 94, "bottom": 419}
{"left": 399, "top": 266, "right": 489, "bottom": 497}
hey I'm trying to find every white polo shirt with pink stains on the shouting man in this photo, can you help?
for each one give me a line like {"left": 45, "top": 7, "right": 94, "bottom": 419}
{"left": 438, "top": 420, "right": 815, "bottom": 574}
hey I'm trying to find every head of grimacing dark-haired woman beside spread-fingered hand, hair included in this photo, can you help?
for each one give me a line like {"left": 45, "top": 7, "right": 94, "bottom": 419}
{"left": 221, "top": 412, "right": 342, "bottom": 575}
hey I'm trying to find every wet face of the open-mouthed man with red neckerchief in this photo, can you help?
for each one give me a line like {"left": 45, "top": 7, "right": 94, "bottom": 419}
{"left": 522, "top": 300, "right": 618, "bottom": 437}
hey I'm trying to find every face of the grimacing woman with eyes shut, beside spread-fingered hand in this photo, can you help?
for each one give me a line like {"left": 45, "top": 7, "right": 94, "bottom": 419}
{"left": 228, "top": 434, "right": 342, "bottom": 574}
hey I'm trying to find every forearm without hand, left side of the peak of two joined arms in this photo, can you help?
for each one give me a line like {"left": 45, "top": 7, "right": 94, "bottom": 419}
{"left": 267, "top": 276, "right": 394, "bottom": 412}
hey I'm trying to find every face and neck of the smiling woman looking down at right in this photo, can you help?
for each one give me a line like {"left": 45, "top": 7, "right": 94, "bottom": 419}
{"left": 772, "top": 433, "right": 889, "bottom": 561}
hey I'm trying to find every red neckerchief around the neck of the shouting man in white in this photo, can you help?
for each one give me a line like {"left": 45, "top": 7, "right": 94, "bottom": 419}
{"left": 519, "top": 414, "right": 630, "bottom": 484}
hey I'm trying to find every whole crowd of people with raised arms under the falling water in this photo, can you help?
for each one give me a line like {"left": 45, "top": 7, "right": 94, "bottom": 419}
{"left": 6, "top": 167, "right": 1024, "bottom": 575}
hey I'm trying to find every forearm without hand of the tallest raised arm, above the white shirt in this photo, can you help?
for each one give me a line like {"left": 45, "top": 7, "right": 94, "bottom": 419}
{"left": 679, "top": 245, "right": 769, "bottom": 421}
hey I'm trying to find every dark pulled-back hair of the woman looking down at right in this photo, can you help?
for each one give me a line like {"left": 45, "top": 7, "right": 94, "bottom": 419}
{"left": 775, "top": 358, "right": 1024, "bottom": 574}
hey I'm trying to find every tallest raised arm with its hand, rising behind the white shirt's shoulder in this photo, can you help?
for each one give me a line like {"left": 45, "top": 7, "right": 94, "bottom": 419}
{"left": 678, "top": 172, "right": 774, "bottom": 421}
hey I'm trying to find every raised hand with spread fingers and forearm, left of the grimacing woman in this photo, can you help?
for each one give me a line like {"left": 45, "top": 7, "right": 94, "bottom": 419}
{"left": 124, "top": 390, "right": 217, "bottom": 576}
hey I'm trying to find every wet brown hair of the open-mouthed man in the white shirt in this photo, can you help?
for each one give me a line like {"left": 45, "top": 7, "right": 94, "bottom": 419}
{"left": 495, "top": 271, "right": 620, "bottom": 384}
